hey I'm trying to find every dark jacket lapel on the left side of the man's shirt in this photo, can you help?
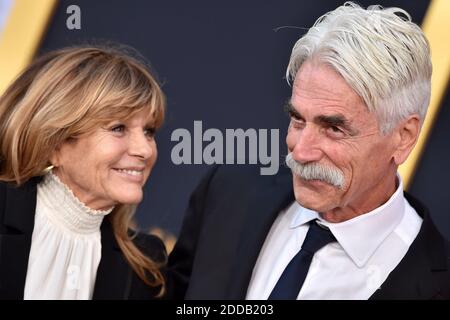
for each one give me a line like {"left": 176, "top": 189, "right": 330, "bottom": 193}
{"left": 227, "top": 172, "right": 294, "bottom": 299}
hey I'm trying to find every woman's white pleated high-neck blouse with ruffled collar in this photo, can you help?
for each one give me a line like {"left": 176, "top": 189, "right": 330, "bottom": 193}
{"left": 24, "top": 172, "right": 112, "bottom": 300}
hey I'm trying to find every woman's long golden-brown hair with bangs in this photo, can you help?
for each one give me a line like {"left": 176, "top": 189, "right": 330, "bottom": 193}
{"left": 0, "top": 47, "right": 165, "bottom": 295}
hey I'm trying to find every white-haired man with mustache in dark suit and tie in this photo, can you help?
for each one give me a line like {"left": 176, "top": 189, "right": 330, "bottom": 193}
{"left": 170, "top": 3, "right": 450, "bottom": 299}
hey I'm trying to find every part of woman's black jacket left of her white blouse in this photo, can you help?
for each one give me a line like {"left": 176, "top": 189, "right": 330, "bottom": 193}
{"left": 0, "top": 178, "right": 40, "bottom": 299}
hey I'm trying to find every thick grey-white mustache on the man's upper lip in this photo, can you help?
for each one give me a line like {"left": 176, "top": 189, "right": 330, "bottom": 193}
{"left": 286, "top": 152, "right": 344, "bottom": 189}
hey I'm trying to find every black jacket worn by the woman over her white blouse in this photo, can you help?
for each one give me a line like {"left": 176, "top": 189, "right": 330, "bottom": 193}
{"left": 0, "top": 178, "right": 166, "bottom": 299}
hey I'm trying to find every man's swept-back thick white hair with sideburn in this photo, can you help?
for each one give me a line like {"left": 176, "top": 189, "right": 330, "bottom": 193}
{"left": 286, "top": 2, "right": 432, "bottom": 134}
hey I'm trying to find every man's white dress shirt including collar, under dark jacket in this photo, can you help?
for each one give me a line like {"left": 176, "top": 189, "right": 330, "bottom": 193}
{"left": 247, "top": 176, "right": 422, "bottom": 300}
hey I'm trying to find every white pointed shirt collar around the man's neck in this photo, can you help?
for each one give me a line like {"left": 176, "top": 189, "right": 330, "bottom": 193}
{"left": 289, "top": 174, "right": 405, "bottom": 268}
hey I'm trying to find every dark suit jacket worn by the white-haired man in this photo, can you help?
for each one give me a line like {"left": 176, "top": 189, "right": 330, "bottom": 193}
{"left": 169, "top": 166, "right": 450, "bottom": 299}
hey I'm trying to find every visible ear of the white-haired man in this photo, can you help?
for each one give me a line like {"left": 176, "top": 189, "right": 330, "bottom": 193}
{"left": 393, "top": 114, "right": 420, "bottom": 166}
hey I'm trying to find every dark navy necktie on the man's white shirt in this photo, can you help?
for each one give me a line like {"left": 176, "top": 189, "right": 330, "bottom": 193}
{"left": 269, "top": 221, "right": 336, "bottom": 300}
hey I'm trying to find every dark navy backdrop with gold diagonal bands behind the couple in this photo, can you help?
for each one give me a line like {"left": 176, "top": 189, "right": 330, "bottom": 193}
{"left": 0, "top": 0, "right": 450, "bottom": 246}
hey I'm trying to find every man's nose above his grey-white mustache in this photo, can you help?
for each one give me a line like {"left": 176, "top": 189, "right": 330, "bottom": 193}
{"left": 291, "top": 125, "right": 323, "bottom": 163}
